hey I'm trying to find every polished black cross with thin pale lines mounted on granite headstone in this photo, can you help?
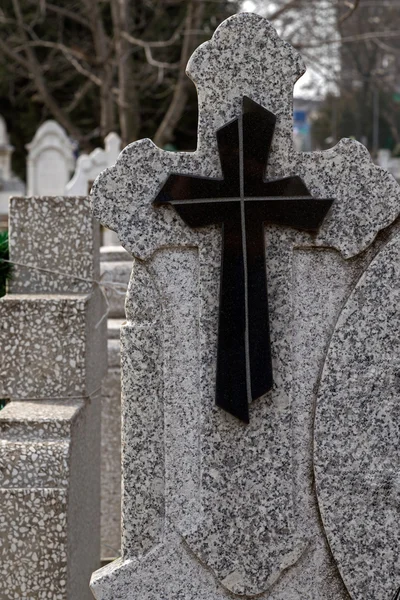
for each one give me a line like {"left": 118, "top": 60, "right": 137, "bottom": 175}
{"left": 154, "top": 97, "right": 333, "bottom": 423}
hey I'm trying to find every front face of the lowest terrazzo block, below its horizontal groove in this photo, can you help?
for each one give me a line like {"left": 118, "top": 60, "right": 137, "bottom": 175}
{"left": 0, "top": 487, "right": 72, "bottom": 600}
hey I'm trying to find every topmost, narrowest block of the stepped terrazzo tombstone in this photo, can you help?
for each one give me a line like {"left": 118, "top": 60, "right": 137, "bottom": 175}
{"left": 9, "top": 196, "right": 100, "bottom": 294}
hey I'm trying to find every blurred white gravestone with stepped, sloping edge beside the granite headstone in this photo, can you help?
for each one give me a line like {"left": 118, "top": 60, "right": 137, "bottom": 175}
{"left": 65, "top": 132, "right": 121, "bottom": 196}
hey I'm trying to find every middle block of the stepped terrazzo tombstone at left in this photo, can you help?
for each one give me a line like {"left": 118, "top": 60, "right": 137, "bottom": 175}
{"left": 0, "top": 290, "right": 107, "bottom": 399}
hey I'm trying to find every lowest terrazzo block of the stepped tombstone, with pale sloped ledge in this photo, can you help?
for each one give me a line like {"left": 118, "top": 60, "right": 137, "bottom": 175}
{"left": 0, "top": 395, "right": 100, "bottom": 600}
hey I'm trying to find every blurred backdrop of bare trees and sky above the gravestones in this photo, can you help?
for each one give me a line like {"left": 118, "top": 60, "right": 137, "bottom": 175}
{"left": 0, "top": 0, "right": 400, "bottom": 183}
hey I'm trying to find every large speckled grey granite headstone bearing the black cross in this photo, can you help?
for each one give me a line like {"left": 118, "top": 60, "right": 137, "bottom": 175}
{"left": 91, "top": 13, "right": 400, "bottom": 600}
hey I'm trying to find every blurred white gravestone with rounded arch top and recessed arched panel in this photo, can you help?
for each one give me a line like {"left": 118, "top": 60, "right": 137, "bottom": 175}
{"left": 26, "top": 121, "right": 75, "bottom": 196}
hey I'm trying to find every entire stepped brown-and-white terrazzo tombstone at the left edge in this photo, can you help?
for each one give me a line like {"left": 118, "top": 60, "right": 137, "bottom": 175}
{"left": 0, "top": 197, "right": 107, "bottom": 600}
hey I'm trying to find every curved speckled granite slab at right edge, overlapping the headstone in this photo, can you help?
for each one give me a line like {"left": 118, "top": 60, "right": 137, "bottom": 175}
{"left": 314, "top": 235, "right": 400, "bottom": 600}
